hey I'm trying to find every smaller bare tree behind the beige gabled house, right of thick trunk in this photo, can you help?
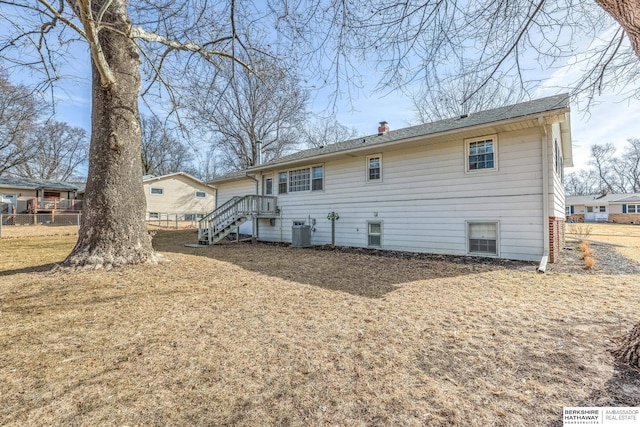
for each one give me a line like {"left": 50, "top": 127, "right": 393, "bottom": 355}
{"left": 140, "top": 116, "right": 194, "bottom": 175}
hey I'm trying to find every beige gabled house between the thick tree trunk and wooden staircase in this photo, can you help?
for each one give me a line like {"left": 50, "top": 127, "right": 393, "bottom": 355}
{"left": 142, "top": 172, "right": 215, "bottom": 221}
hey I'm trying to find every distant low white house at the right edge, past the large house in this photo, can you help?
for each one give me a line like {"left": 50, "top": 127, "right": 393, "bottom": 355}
{"left": 565, "top": 193, "right": 640, "bottom": 224}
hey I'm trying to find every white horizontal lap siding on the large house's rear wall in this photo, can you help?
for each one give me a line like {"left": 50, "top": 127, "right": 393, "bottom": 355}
{"left": 218, "top": 129, "right": 543, "bottom": 261}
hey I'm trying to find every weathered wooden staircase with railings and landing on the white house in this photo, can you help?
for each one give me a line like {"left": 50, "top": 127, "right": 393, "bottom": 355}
{"left": 198, "top": 195, "right": 278, "bottom": 245}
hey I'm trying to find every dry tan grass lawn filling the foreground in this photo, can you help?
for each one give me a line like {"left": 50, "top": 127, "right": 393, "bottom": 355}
{"left": 0, "top": 226, "right": 640, "bottom": 426}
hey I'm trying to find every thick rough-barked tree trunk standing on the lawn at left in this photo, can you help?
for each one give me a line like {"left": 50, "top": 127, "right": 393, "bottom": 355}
{"left": 64, "top": 0, "right": 155, "bottom": 267}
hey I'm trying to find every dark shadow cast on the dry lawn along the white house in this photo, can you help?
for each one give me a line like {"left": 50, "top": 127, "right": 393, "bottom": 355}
{"left": 154, "top": 231, "right": 535, "bottom": 298}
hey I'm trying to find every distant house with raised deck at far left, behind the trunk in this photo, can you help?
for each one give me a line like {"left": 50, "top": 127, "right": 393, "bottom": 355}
{"left": 0, "top": 176, "right": 82, "bottom": 213}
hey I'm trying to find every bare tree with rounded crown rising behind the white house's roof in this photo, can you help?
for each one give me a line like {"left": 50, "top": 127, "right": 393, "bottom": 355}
{"left": 189, "top": 54, "right": 309, "bottom": 170}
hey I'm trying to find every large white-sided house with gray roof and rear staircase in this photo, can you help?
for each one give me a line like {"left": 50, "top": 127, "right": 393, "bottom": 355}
{"left": 206, "top": 95, "right": 572, "bottom": 262}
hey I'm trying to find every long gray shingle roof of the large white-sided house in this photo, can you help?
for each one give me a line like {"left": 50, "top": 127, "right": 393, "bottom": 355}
{"left": 211, "top": 94, "right": 569, "bottom": 183}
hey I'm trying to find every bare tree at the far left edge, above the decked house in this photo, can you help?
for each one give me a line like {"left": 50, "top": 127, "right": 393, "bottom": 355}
{"left": 0, "top": 72, "right": 45, "bottom": 175}
